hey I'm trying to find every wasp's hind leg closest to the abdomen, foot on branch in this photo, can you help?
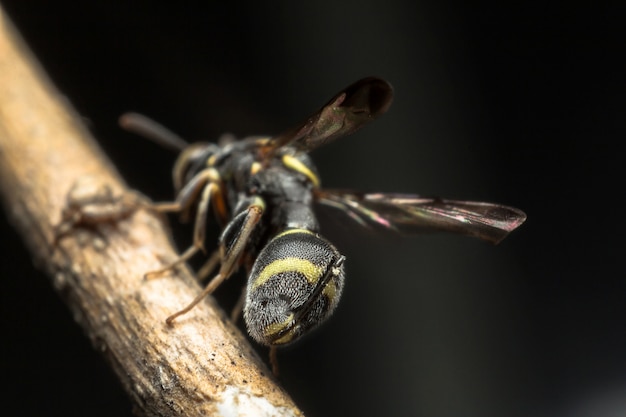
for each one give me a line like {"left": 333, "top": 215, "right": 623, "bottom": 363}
{"left": 165, "top": 203, "right": 263, "bottom": 325}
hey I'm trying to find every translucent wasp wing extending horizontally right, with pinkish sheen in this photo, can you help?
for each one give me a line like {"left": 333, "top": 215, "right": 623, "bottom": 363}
{"left": 317, "top": 190, "right": 526, "bottom": 243}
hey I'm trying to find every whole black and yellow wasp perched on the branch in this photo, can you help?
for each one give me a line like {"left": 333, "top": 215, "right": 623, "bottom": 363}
{"left": 121, "top": 77, "right": 526, "bottom": 358}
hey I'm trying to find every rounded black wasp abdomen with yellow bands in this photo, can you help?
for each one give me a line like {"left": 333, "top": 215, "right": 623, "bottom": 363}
{"left": 244, "top": 229, "right": 345, "bottom": 345}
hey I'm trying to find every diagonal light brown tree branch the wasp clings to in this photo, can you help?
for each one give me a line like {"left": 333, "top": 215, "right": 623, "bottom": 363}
{"left": 0, "top": 10, "right": 301, "bottom": 416}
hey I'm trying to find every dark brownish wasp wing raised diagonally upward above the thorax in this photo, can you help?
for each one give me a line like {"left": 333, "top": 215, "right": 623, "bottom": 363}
{"left": 269, "top": 77, "right": 393, "bottom": 152}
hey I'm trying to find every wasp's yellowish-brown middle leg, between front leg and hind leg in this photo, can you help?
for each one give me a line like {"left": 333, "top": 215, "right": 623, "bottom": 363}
{"left": 144, "top": 171, "right": 220, "bottom": 279}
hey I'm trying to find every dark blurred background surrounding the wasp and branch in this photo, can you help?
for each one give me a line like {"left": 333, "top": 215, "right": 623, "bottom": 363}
{"left": 0, "top": 0, "right": 626, "bottom": 417}
